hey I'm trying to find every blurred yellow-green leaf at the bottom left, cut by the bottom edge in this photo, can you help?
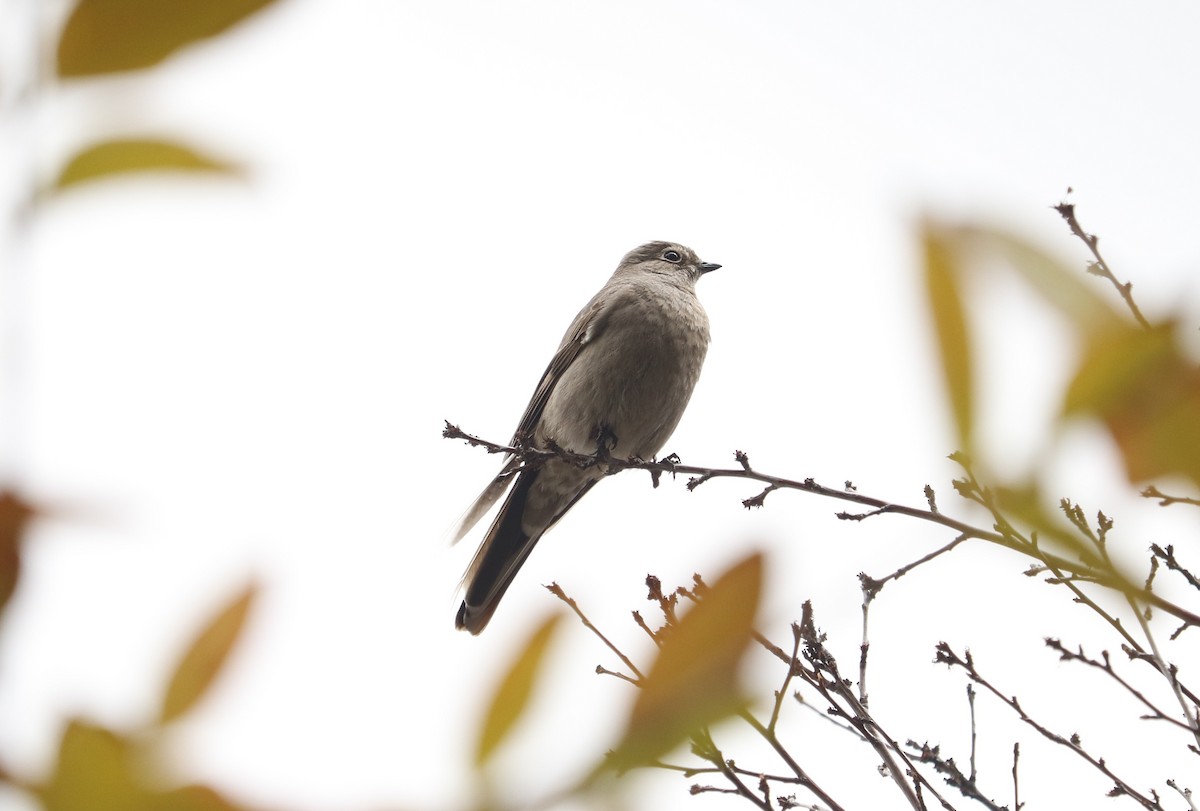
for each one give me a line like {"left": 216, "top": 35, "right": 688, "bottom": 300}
{"left": 40, "top": 720, "right": 141, "bottom": 811}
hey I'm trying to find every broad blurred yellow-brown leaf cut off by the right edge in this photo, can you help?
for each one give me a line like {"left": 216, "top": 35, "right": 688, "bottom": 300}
{"left": 1063, "top": 323, "right": 1200, "bottom": 485}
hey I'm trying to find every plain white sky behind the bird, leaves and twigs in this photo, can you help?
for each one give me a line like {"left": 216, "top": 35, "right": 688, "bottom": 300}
{"left": 0, "top": 0, "right": 1200, "bottom": 810}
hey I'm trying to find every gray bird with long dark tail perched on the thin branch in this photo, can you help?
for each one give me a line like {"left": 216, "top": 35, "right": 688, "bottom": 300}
{"left": 454, "top": 242, "right": 720, "bottom": 633}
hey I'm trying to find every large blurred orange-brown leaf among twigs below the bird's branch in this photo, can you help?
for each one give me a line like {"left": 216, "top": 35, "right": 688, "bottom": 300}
{"left": 607, "top": 553, "right": 762, "bottom": 771}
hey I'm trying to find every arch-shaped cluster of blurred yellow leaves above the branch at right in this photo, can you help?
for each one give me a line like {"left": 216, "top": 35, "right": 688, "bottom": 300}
{"left": 924, "top": 217, "right": 1200, "bottom": 483}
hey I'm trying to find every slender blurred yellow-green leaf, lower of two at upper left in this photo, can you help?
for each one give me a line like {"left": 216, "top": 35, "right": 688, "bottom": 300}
{"left": 52, "top": 138, "right": 239, "bottom": 191}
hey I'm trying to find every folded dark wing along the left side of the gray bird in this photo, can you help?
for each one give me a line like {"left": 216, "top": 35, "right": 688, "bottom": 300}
{"left": 450, "top": 291, "right": 608, "bottom": 543}
